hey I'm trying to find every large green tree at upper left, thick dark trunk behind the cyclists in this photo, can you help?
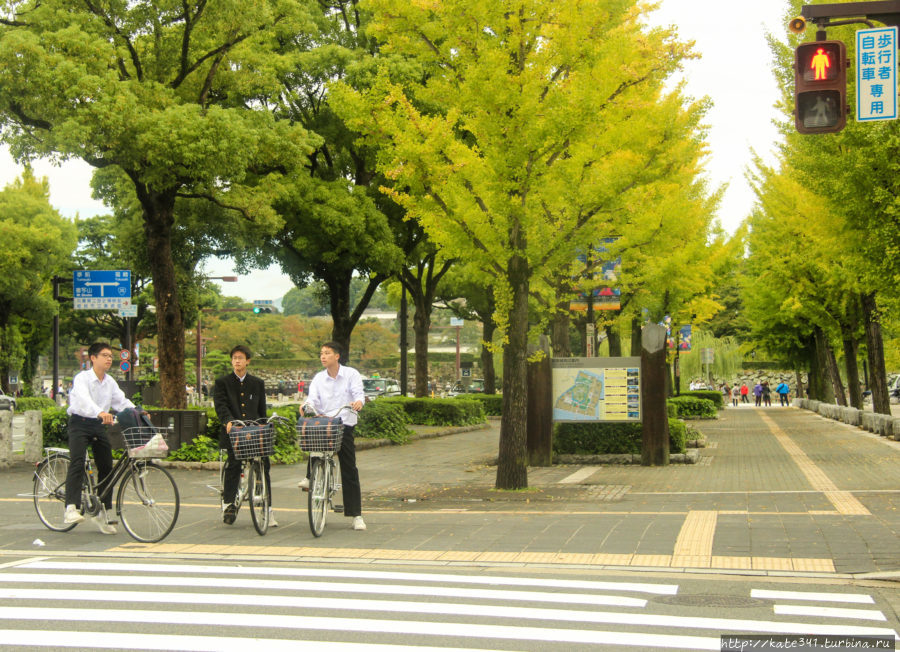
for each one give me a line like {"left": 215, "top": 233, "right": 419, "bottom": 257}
{"left": 0, "top": 0, "right": 314, "bottom": 407}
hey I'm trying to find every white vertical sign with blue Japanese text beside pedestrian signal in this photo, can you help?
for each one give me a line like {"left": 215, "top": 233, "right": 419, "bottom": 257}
{"left": 856, "top": 27, "right": 897, "bottom": 122}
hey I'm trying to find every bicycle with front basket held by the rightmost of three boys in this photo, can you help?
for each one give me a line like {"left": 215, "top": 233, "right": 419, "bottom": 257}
{"left": 297, "top": 405, "right": 353, "bottom": 537}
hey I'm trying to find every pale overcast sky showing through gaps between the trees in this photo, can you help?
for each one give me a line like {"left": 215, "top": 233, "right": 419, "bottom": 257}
{"left": 0, "top": 0, "right": 787, "bottom": 301}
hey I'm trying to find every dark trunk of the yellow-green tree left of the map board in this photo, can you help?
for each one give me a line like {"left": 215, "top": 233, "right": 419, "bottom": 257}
{"left": 496, "top": 252, "right": 528, "bottom": 489}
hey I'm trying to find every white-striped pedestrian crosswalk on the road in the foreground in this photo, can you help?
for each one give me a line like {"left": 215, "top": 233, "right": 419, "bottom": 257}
{"left": 0, "top": 558, "right": 897, "bottom": 652}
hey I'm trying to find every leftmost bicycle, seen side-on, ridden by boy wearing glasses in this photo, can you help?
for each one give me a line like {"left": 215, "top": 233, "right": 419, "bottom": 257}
{"left": 26, "top": 426, "right": 181, "bottom": 543}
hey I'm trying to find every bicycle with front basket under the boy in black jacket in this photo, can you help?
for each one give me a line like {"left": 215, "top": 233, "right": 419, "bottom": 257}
{"left": 215, "top": 415, "right": 284, "bottom": 536}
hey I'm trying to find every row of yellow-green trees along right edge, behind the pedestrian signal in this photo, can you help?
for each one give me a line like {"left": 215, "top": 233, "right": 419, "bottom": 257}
{"left": 744, "top": 2, "right": 900, "bottom": 414}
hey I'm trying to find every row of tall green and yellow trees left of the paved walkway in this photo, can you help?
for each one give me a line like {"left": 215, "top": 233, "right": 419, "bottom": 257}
{"left": 0, "top": 0, "right": 737, "bottom": 488}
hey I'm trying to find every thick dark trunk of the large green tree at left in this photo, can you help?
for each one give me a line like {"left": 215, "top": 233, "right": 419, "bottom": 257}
{"left": 135, "top": 183, "right": 187, "bottom": 409}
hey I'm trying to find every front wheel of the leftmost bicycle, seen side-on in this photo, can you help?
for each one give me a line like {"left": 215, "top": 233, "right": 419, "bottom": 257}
{"left": 116, "top": 462, "right": 181, "bottom": 543}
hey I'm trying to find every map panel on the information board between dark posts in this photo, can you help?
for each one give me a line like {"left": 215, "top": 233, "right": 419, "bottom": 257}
{"left": 552, "top": 357, "right": 641, "bottom": 421}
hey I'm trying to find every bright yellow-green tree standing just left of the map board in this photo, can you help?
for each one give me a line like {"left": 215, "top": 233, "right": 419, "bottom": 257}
{"left": 333, "top": 0, "right": 700, "bottom": 489}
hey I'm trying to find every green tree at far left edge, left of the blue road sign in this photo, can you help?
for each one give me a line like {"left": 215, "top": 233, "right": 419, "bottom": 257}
{"left": 0, "top": 169, "right": 76, "bottom": 392}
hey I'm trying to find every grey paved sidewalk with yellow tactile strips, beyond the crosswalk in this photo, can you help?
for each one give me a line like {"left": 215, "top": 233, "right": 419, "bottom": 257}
{"left": 0, "top": 407, "right": 900, "bottom": 576}
